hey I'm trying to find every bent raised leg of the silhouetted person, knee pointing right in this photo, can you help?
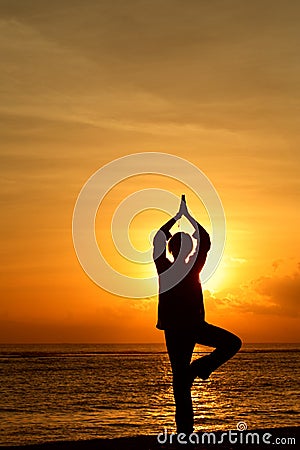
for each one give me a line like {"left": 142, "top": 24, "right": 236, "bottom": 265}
{"left": 191, "top": 322, "right": 242, "bottom": 380}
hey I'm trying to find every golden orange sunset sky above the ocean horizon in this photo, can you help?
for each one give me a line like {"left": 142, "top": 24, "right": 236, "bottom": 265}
{"left": 0, "top": 0, "right": 300, "bottom": 342}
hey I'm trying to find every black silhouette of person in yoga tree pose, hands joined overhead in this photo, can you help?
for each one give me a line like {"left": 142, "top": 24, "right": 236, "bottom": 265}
{"left": 153, "top": 196, "right": 242, "bottom": 435}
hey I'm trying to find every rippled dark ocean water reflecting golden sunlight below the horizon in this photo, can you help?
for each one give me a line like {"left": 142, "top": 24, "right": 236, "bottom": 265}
{"left": 0, "top": 344, "right": 300, "bottom": 445}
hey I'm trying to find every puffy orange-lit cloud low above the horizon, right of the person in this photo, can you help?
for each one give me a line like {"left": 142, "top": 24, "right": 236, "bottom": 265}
{"left": 205, "top": 264, "right": 300, "bottom": 317}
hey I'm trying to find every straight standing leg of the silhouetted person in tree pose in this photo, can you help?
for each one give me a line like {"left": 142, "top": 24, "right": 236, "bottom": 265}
{"left": 165, "top": 330, "right": 195, "bottom": 435}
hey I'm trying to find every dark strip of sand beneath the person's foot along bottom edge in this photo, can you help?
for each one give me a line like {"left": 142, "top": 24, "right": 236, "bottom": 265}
{"left": 0, "top": 427, "right": 300, "bottom": 450}
